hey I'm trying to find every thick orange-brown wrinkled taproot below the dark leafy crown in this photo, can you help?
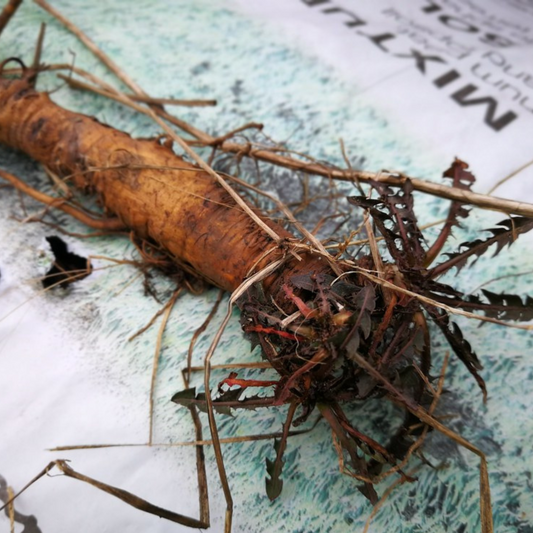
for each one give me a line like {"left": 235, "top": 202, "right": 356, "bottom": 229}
{"left": 0, "top": 79, "right": 300, "bottom": 291}
